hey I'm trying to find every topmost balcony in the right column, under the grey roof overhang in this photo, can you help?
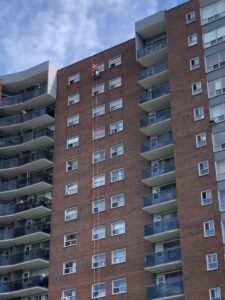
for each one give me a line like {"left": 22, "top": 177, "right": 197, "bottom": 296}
{"left": 137, "top": 36, "right": 168, "bottom": 67}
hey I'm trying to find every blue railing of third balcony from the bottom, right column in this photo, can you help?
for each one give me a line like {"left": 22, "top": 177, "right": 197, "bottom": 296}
{"left": 144, "top": 217, "right": 179, "bottom": 236}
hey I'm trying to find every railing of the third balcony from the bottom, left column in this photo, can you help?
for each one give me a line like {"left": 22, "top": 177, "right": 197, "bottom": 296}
{"left": 0, "top": 223, "right": 50, "bottom": 240}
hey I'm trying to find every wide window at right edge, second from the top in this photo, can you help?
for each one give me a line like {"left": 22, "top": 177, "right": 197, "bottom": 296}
{"left": 203, "top": 26, "right": 225, "bottom": 48}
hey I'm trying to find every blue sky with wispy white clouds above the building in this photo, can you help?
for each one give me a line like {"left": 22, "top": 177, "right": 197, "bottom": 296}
{"left": 0, "top": 0, "right": 186, "bottom": 74}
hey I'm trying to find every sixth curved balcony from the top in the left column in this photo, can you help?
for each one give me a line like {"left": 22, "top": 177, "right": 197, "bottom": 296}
{"left": 0, "top": 197, "right": 52, "bottom": 224}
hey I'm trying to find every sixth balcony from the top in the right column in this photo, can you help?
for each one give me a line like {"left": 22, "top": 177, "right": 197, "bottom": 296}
{"left": 142, "top": 159, "right": 175, "bottom": 187}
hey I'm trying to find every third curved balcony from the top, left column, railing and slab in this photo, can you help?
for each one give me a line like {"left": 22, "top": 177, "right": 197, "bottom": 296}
{"left": 0, "top": 128, "right": 55, "bottom": 156}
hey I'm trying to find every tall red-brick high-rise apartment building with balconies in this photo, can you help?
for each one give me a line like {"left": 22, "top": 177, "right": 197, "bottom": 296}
{"left": 0, "top": 0, "right": 225, "bottom": 300}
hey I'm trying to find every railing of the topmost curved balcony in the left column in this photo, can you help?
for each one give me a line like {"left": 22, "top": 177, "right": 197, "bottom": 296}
{"left": 1, "top": 83, "right": 47, "bottom": 106}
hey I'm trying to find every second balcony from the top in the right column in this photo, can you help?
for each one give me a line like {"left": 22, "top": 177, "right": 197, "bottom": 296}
{"left": 138, "top": 60, "right": 168, "bottom": 89}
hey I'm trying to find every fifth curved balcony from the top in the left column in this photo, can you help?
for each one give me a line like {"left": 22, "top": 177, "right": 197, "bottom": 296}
{"left": 0, "top": 170, "right": 52, "bottom": 201}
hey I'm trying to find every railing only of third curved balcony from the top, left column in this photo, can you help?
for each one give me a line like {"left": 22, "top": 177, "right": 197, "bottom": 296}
{"left": 0, "top": 128, "right": 54, "bottom": 147}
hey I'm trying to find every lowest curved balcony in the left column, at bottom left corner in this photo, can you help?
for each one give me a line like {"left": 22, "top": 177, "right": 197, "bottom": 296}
{"left": 0, "top": 276, "right": 48, "bottom": 300}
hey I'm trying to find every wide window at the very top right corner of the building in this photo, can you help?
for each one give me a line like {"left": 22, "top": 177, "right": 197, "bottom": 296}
{"left": 201, "top": 0, "right": 225, "bottom": 24}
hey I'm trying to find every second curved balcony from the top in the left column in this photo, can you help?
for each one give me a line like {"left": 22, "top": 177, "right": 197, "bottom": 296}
{"left": 0, "top": 105, "right": 55, "bottom": 135}
